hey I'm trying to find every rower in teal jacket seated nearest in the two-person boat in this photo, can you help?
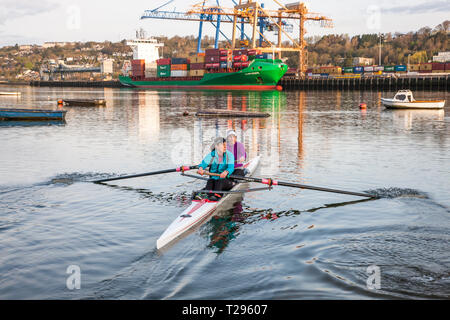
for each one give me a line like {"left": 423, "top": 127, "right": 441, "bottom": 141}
{"left": 196, "top": 138, "right": 234, "bottom": 201}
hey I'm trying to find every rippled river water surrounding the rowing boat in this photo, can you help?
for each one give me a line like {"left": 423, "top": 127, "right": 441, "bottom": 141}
{"left": 0, "top": 87, "right": 450, "bottom": 299}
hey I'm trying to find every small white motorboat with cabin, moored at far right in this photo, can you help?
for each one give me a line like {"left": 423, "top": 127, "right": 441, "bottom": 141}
{"left": 381, "top": 90, "right": 445, "bottom": 109}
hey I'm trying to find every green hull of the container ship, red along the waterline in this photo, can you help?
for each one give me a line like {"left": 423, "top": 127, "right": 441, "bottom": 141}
{"left": 119, "top": 59, "right": 287, "bottom": 90}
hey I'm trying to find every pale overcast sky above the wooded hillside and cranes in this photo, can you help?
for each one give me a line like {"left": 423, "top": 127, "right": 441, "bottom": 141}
{"left": 0, "top": 0, "right": 450, "bottom": 47}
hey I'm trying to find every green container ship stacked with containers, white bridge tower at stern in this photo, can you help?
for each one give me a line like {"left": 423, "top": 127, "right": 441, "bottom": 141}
{"left": 119, "top": 39, "right": 288, "bottom": 90}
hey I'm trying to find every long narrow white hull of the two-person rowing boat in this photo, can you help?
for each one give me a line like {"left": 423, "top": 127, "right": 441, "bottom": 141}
{"left": 156, "top": 156, "right": 260, "bottom": 249}
